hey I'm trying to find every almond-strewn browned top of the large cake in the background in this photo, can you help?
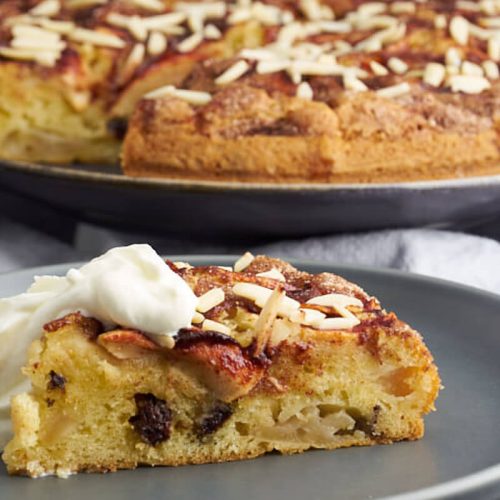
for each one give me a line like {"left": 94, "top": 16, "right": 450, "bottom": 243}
{"left": 0, "top": 0, "right": 500, "bottom": 104}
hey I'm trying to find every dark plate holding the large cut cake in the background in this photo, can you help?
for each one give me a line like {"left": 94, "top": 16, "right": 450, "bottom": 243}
{"left": 0, "top": 161, "right": 500, "bottom": 239}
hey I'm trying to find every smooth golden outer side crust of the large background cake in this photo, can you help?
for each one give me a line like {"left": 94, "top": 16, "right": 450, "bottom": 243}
{"left": 122, "top": 128, "right": 500, "bottom": 184}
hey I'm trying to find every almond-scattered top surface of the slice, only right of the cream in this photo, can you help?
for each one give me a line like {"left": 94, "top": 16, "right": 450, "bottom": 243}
{"left": 169, "top": 253, "right": 414, "bottom": 346}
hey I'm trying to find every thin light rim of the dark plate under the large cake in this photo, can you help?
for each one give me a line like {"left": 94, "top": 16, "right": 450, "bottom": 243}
{"left": 0, "top": 158, "right": 500, "bottom": 193}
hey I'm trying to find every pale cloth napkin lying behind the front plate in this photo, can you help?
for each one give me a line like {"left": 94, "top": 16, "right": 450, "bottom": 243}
{"left": 0, "top": 217, "right": 500, "bottom": 293}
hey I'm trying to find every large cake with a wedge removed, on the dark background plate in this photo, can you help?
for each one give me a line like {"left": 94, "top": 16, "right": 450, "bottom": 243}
{"left": 0, "top": 0, "right": 500, "bottom": 182}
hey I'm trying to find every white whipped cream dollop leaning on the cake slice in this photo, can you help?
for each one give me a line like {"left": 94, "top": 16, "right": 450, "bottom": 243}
{"left": 0, "top": 245, "right": 197, "bottom": 449}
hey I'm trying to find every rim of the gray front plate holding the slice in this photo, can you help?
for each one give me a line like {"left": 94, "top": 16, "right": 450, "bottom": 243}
{"left": 0, "top": 254, "right": 500, "bottom": 500}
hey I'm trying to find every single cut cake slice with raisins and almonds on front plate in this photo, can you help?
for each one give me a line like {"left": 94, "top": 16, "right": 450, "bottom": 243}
{"left": 3, "top": 254, "right": 440, "bottom": 477}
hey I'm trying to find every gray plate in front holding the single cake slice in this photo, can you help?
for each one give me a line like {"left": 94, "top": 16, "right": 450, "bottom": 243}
{"left": 0, "top": 256, "right": 500, "bottom": 500}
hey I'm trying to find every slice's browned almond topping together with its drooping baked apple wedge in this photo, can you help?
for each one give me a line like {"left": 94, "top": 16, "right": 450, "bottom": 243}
{"left": 44, "top": 253, "right": 422, "bottom": 401}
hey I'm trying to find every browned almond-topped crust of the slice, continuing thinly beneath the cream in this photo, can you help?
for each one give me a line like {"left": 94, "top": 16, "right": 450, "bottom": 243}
{"left": 44, "top": 252, "right": 416, "bottom": 364}
